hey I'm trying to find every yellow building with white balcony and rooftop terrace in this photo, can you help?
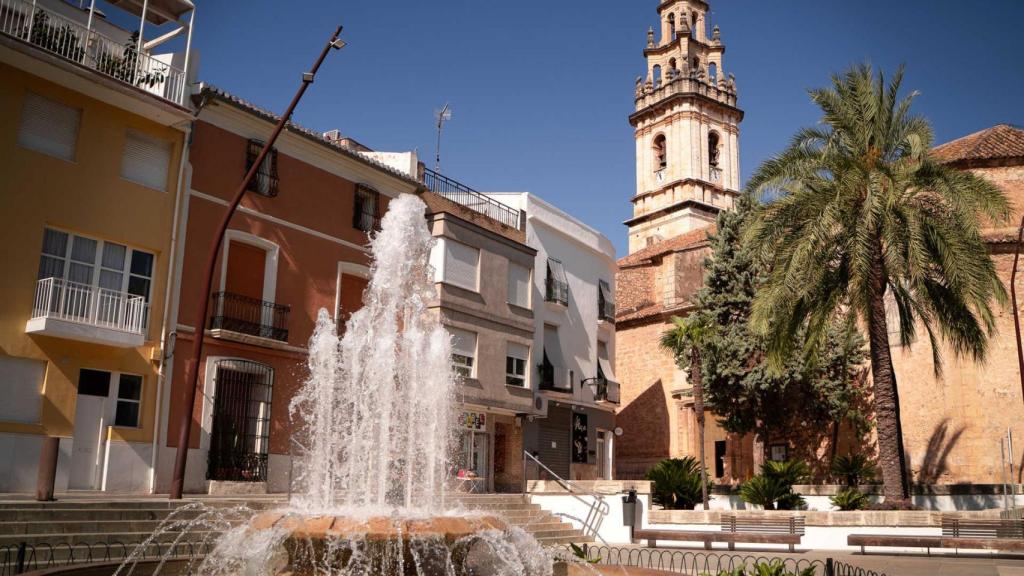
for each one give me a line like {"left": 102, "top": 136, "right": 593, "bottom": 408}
{"left": 0, "top": 0, "right": 194, "bottom": 492}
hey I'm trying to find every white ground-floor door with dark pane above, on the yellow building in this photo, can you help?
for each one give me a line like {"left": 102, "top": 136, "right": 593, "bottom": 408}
{"left": 68, "top": 370, "right": 111, "bottom": 490}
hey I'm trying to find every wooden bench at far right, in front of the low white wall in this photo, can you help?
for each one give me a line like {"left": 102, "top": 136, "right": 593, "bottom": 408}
{"left": 846, "top": 516, "right": 1024, "bottom": 554}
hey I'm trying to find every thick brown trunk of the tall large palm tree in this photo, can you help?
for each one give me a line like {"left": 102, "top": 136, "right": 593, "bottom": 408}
{"left": 867, "top": 247, "right": 909, "bottom": 502}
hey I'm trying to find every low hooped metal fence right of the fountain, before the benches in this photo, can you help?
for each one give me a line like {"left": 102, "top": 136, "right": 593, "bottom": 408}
{"left": 559, "top": 544, "right": 885, "bottom": 576}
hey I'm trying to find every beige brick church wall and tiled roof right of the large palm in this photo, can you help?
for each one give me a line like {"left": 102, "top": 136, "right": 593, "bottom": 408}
{"left": 893, "top": 125, "right": 1024, "bottom": 485}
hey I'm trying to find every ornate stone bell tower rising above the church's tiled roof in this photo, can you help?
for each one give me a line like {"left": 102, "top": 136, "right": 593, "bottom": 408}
{"left": 625, "top": 0, "right": 743, "bottom": 254}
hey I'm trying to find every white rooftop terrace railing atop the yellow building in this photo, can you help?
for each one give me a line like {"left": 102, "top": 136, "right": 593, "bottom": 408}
{"left": 0, "top": 0, "right": 185, "bottom": 105}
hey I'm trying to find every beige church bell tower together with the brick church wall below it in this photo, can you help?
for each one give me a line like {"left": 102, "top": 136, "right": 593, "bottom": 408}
{"left": 615, "top": 0, "right": 750, "bottom": 480}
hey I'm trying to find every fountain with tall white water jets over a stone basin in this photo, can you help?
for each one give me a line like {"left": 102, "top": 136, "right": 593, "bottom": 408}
{"left": 108, "top": 195, "right": 663, "bottom": 576}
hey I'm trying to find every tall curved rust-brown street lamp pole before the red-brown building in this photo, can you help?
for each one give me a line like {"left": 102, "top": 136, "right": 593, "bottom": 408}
{"left": 170, "top": 26, "right": 345, "bottom": 500}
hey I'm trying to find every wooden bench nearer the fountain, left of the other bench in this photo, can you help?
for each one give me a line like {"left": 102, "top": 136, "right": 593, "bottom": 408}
{"left": 633, "top": 515, "right": 805, "bottom": 551}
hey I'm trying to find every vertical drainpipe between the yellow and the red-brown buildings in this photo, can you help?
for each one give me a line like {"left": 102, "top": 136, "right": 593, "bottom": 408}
{"left": 150, "top": 112, "right": 198, "bottom": 494}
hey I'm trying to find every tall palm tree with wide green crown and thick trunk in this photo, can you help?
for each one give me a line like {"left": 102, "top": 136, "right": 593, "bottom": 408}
{"left": 744, "top": 65, "right": 1009, "bottom": 501}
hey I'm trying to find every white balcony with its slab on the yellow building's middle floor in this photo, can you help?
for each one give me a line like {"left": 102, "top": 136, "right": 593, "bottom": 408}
{"left": 25, "top": 278, "right": 146, "bottom": 347}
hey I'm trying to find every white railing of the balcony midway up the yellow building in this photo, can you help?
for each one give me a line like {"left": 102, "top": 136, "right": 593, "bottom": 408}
{"left": 32, "top": 278, "right": 145, "bottom": 335}
